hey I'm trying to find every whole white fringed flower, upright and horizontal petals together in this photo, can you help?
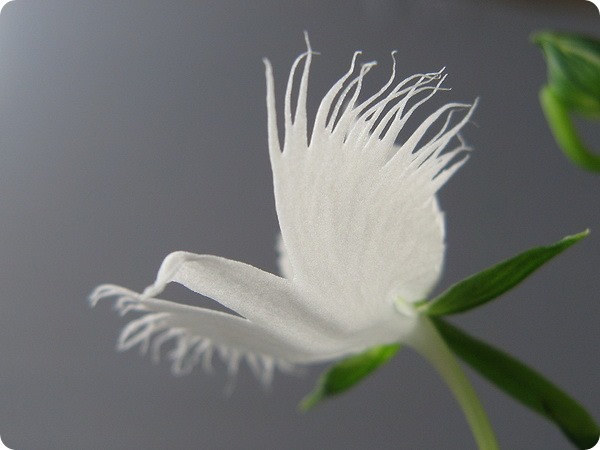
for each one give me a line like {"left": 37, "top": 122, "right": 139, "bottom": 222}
{"left": 90, "top": 40, "right": 473, "bottom": 383}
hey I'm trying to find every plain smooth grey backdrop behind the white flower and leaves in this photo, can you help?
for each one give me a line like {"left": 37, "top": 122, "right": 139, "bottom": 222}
{"left": 0, "top": 0, "right": 600, "bottom": 450}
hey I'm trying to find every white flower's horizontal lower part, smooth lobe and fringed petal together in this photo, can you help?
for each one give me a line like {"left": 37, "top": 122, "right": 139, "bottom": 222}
{"left": 90, "top": 252, "right": 418, "bottom": 373}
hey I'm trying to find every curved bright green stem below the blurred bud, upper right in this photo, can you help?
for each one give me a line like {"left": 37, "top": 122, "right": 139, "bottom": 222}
{"left": 540, "top": 86, "right": 600, "bottom": 172}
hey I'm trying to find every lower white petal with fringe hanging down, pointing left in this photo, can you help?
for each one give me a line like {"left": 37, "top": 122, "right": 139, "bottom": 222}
{"left": 90, "top": 285, "right": 306, "bottom": 385}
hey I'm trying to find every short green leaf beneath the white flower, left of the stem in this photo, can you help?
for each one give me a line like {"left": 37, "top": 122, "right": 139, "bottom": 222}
{"left": 300, "top": 344, "right": 400, "bottom": 411}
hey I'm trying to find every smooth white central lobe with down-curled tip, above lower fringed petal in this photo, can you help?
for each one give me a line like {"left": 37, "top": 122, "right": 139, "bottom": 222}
{"left": 142, "top": 252, "right": 412, "bottom": 348}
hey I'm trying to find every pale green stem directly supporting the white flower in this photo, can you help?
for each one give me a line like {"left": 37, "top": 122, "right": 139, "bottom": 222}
{"left": 408, "top": 317, "right": 499, "bottom": 450}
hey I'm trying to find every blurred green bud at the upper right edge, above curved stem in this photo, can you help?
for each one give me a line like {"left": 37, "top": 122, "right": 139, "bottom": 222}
{"left": 532, "top": 32, "right": 600, "bottom": 117}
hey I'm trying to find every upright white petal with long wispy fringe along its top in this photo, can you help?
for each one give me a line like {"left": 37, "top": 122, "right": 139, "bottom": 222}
{"left": 267, "top": 44, "right": 473, "bottom": 312}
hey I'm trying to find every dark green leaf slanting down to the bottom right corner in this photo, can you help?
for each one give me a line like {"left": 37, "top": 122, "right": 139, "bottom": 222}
{"left": 433, "top": 318, "right": 600, "bottom": 449}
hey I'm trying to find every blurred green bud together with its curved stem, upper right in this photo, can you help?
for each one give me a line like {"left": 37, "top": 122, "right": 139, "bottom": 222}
{"left": 533, "top": 32, "right": 600, "bottom": 172}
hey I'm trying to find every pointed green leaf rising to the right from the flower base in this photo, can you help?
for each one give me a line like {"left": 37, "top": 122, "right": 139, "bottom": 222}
{"left": 418, "top": 230, "right": 589, "bottom": 316}
